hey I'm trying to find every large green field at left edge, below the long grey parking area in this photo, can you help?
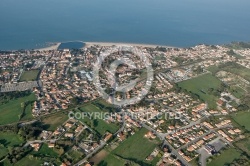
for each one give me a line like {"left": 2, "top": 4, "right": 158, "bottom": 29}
{"left": 0, "top": 93, "right": 36, "bottom": 125}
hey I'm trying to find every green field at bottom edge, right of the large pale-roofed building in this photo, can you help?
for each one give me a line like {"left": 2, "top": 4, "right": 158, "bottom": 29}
{"left": 207, "top": 148, "right": 240, "bottom": 166}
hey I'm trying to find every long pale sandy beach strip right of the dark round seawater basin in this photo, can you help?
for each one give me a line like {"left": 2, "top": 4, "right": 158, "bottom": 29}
{"left": 84, "top": 42, "right": 175, "bottom": 48}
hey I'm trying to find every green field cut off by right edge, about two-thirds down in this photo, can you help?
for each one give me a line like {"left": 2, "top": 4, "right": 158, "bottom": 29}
{"left": 233, "top": 112, "right": 250, "bottom": 131}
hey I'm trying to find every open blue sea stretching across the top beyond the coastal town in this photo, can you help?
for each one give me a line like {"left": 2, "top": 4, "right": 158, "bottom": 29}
{"left": 0, "top": 0, "right": 250, "bottom": 50}
